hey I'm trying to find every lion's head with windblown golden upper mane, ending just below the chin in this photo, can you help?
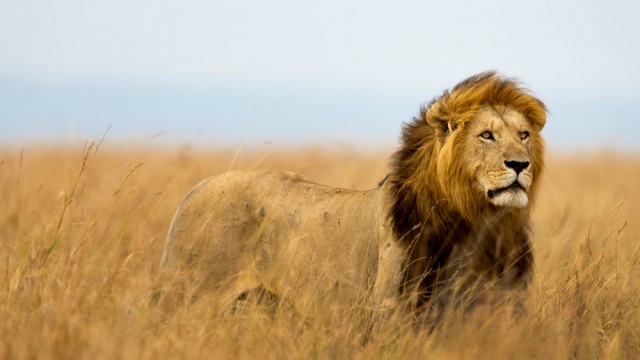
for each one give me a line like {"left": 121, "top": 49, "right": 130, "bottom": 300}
{"left": 392, "top": 72, "right": 546, "bottom": 230}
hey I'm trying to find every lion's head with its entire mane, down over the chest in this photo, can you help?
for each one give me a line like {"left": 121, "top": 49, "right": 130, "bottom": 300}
{"left": 387, "top": 72, "right": 546, "bottom": 306}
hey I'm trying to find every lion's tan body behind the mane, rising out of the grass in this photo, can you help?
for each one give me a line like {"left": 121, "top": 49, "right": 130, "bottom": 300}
{"left": 162, "top": 170, "right": 388, "bottom": 308}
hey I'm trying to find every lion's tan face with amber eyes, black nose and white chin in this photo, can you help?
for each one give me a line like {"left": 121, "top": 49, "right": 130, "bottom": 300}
{"left": 464, "top": 107, "right": 541, "bottom": 208}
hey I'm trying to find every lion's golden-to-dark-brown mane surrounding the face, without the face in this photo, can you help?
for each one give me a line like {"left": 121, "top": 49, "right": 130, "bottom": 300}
{"left": 387, "top": 72, "right": 546, "bottom": 306}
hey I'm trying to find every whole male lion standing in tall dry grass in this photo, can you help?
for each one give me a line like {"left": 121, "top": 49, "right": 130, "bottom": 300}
{"left": 161, "top": 72, "right": 546, "bottom": 320}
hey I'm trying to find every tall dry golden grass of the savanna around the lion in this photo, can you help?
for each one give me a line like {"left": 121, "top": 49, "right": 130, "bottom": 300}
{"left": 0, "top": 141, "right": 640, "bottom": 359}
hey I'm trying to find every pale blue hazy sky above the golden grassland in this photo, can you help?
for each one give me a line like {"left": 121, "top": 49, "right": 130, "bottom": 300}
{"left": 0, "top": 0, "right": 640, "bottom": 150}
